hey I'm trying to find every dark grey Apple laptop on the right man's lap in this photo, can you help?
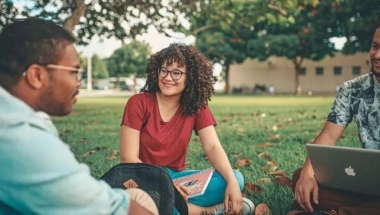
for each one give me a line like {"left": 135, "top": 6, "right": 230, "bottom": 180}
{"left": 306, "top": 143, "right": 380, "bottom": 196}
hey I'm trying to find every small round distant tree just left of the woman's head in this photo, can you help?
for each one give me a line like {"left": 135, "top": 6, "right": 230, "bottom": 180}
{"left": 107, "top": 40, "right": 152, "bottom": 93}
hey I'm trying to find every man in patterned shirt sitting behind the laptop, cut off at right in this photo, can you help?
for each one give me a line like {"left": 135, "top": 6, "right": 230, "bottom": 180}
{"left": 288, "top": 17, "right": 380, "bottom": 215}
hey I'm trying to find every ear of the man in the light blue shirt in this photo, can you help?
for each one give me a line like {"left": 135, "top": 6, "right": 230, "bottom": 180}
{"left": 24, "top": 64, "right": 49, "bottom": 89}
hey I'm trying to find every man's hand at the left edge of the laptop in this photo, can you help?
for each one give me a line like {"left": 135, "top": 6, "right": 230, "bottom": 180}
{"left": 294, "top": 171, "right": 318, "bottom": 211}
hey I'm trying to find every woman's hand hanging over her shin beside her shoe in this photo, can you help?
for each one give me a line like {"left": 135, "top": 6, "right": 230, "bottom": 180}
{"left": 224, "top": 180, "right": 243, "bottom": 214}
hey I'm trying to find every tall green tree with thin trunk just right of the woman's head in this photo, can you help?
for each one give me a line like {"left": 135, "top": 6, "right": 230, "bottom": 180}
{"left": 171, "top": 0, "right": 313, "bottom": 93}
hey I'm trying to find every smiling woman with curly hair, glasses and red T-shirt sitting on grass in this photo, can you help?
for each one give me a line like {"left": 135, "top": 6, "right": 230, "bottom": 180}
{"left": 120, "top": 43, "right": 253, "bottom": 215}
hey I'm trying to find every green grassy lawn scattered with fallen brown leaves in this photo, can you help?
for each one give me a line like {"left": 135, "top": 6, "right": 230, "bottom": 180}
{"left": 54, "top": 95, "right": 359, "bottom": 215}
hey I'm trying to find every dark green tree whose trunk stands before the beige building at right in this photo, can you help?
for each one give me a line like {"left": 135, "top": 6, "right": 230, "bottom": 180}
{"left": 248, "top": 0, "right": 342, "bottom": 94}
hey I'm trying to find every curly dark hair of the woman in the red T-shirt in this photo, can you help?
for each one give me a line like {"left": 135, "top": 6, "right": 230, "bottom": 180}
{"left": 141, "top": 43, "right": 217, "bottom": 116}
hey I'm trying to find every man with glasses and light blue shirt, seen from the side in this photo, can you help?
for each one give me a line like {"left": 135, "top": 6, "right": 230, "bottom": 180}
{"left": 0, "top": 19, "right": 158, "bottom": 215}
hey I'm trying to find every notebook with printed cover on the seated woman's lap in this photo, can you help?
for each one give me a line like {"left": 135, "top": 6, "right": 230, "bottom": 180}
{"left": 173, "top": 168, "right": 215, "bottom": 199}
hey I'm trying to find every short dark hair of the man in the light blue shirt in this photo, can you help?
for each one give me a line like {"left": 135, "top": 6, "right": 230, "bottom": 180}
{"left": 0, "top": 18, "right": 75, "bottom": 85}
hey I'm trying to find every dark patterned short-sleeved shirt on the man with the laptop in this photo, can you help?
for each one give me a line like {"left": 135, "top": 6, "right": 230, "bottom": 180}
{"left": 327, "top": 73, "right": 380, "bottom": 149}
